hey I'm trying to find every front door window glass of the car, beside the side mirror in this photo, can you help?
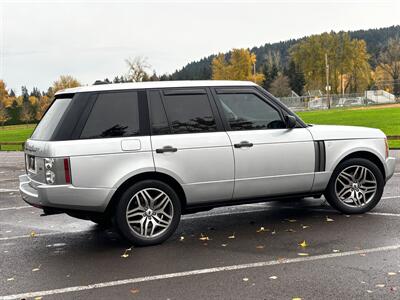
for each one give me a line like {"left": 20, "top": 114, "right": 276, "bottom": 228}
{"left": 217, "top": 93, "right": 286, "bottom": 130}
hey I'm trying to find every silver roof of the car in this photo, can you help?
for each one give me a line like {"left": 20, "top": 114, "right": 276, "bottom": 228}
{"left": 56, "top": 80, "right": 256, "bottom": 95}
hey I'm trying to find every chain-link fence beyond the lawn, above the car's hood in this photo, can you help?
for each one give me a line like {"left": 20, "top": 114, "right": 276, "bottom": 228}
{"left": 279, "top": 90, "right": 396, "bottom": 111}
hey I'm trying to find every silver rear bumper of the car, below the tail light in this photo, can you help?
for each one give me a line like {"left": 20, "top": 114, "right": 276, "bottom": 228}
{"left": 19, "top": 175, "right": 115, "bottom": 212}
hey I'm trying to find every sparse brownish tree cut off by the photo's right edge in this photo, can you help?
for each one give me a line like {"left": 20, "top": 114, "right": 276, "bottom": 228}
{"left": 379, "top": 37, "right": 400, "bottom": 96}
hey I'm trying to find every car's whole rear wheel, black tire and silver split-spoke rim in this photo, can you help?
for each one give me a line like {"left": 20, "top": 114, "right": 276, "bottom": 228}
{"left": 115, "top": 180, "right": 181, "bottom": 246}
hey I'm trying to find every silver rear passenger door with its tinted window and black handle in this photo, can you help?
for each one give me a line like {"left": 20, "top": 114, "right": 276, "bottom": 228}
{"left": 148, "top": 88, "right": 234, "bottom": 204}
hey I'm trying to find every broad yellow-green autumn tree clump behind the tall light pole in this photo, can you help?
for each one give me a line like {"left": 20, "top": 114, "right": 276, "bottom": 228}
{"left": 291, "top": 32, "right": 371, "bottom": 93}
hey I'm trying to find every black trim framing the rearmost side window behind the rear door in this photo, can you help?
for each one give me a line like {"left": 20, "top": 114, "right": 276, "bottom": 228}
{"left": 71, "top": 89, "right": 150, "bottom": 140}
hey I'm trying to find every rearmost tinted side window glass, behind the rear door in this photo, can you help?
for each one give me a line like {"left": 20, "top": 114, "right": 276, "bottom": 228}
{"left": 81, "top": 92, "right": 139, "bottom": 139}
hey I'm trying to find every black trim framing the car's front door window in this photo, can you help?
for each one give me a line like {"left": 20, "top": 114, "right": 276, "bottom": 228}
{"left": 211, "top": 86, "right": 285, "bottom": 131}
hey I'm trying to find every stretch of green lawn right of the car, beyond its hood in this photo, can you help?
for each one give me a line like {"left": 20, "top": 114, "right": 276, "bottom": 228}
{"left": 298, "top": 107, "right": 400, "bottom": 148}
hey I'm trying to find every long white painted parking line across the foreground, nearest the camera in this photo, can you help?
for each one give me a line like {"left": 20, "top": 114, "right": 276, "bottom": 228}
{"left": 0, "top": 244, "right": 400, "bottom": 300}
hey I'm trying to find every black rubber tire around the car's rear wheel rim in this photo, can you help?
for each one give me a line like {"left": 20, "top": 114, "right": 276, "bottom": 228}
{"left": 115, "top": 180, "right": 181, "bottom": 246}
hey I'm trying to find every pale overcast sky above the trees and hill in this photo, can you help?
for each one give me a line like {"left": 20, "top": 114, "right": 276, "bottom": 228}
{"left": 0, "top": 0, "right": 400, "bottom": 93}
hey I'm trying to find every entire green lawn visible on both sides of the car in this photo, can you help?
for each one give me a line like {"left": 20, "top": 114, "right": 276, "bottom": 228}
{"left": 0, "top": 107, "right": 400, "bottom": 150}
